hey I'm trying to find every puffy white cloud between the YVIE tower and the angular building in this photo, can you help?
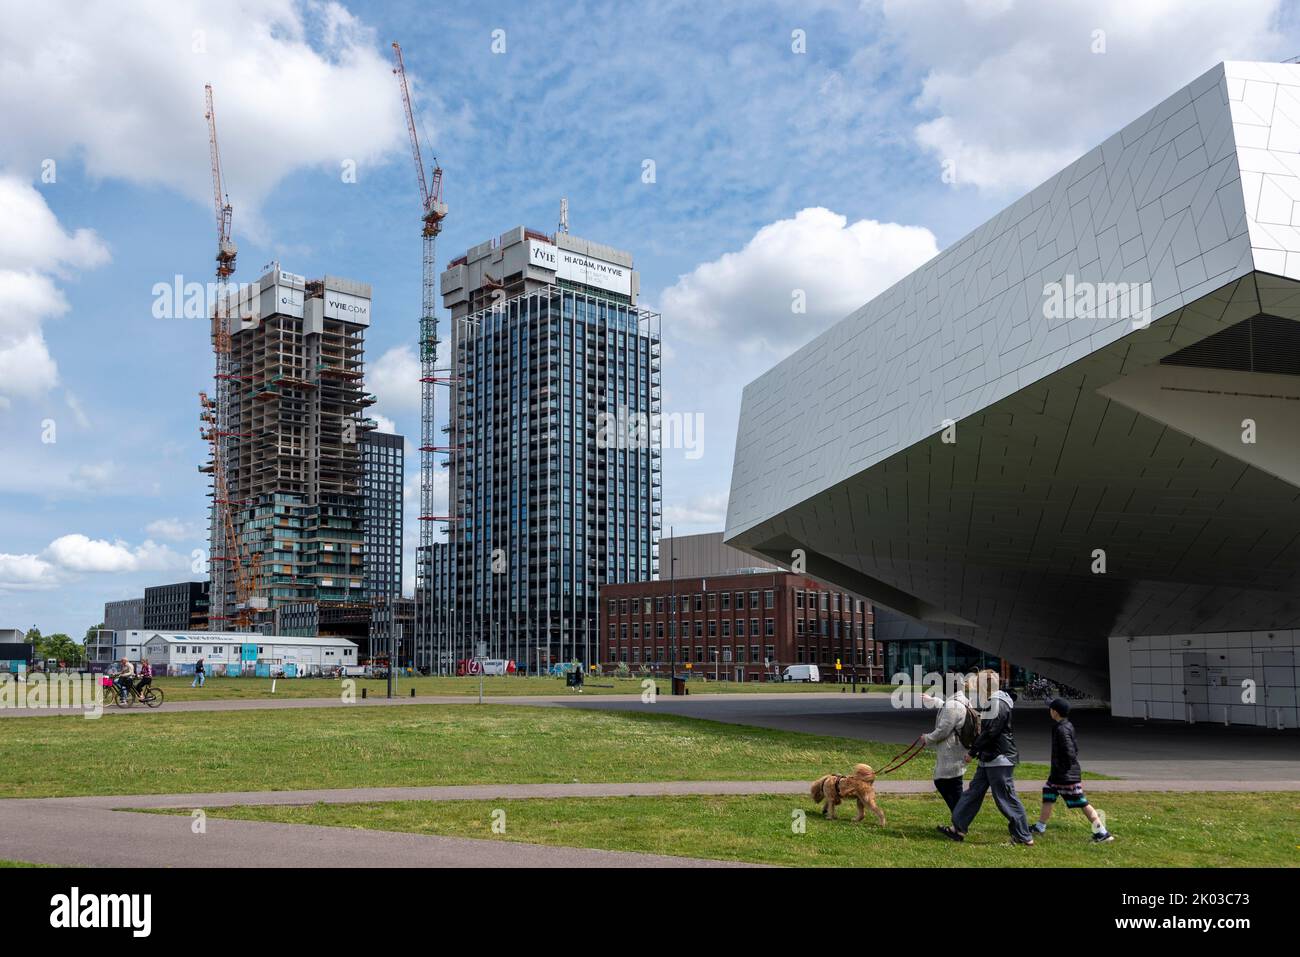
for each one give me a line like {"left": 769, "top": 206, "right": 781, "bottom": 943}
{"left": 662, "top": 207, "right": 939, "bottom": 354}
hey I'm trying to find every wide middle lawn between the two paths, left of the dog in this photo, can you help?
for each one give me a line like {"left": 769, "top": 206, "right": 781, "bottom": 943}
{"left": 0, "top": 705, "right": 1047, "bottom": 797}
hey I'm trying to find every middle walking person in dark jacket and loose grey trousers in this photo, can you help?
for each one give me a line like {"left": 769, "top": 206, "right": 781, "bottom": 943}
{"left": 939, "top": 670, "right": 1034, "bottom": 846}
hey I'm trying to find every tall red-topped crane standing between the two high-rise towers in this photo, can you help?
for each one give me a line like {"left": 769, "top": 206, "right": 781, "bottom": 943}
{"left": 393, "top": 43, "right": 450, "bottom": 671}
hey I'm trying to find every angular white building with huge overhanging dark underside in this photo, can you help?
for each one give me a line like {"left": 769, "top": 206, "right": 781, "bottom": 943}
{"left": 727, "top": 62, "right": 1300, "bottom": 690}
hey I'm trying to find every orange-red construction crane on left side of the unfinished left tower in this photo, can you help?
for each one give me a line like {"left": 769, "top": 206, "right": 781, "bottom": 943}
{"left": 199, "top": 83, "right": 261, "bottom": 631}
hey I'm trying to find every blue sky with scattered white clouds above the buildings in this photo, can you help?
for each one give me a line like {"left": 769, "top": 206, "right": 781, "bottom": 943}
{"left": 0, "top": 0, "right": 1300, "bottom": 637}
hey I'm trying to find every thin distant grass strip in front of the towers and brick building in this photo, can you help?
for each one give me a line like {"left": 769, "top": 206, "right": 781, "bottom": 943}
{"left": 139, "top": 676, "right": 893, "bottom": 701}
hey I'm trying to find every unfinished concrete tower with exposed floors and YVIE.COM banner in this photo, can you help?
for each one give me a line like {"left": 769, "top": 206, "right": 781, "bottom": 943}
{"left": 212, "top": 265, "right": 374, "bottom": 629}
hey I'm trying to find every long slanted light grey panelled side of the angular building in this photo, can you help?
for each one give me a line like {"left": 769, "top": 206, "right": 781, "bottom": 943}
{"left": 727, "top": 64, "right": 1279, "bottom": 538}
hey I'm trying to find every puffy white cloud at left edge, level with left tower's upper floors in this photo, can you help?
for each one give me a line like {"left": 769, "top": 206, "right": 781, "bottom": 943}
{"left": 0, "top": 178, "right": 108, "bottom": 407}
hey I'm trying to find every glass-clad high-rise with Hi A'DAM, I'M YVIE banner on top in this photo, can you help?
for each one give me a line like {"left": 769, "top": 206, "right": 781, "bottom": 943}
{"left": 416, "top": 226, "right": 662, "bottom": 671}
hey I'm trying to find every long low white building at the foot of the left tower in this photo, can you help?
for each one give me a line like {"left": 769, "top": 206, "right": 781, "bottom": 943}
{"left": 113, "top": 631, "right": 356, "bottom": 677}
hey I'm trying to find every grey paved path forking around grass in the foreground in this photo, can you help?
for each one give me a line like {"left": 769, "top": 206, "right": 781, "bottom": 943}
{"left": 0, "top": 780, "right": 1300, "bottom": 867}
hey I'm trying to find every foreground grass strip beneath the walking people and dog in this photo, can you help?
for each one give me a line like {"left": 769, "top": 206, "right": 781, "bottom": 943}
{"left": 172, "top": 793, "right": 1300, "bottom": 867}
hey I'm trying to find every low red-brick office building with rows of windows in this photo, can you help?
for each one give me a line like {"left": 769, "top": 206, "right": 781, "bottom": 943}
{"left": 599, "top": 571, "right": 884, "bottom": 681}
